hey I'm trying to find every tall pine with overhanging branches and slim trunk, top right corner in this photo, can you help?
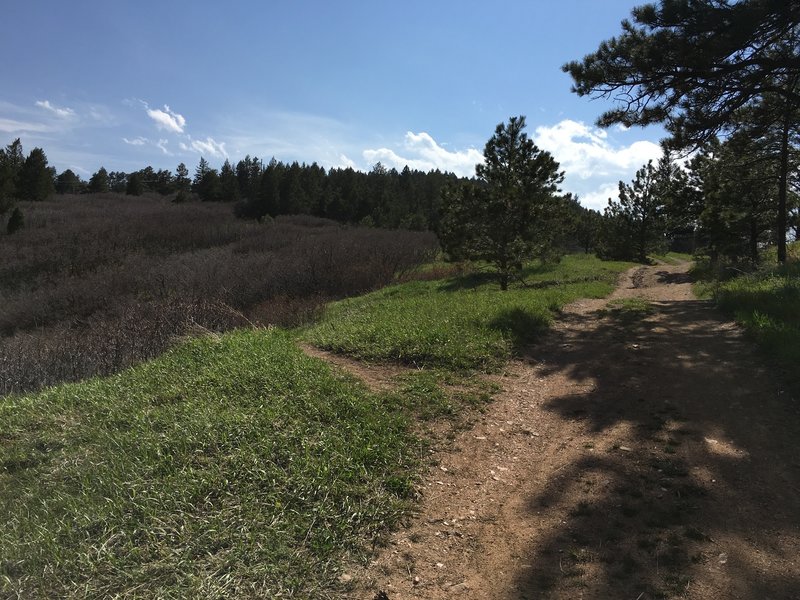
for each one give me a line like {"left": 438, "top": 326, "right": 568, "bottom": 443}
{"left": 563, "top": 0, "right": 800, "bottom": 263}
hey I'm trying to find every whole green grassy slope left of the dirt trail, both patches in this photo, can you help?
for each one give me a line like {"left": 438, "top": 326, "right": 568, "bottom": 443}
{"left": 0, "top": 257, "right": 628, "bottom": 598}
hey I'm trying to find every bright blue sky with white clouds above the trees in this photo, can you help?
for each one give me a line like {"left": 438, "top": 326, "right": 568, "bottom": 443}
{"left": 0, "top": 0, "right": 663, "bottom": 208}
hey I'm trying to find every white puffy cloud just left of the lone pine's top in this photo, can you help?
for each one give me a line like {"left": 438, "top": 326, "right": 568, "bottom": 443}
{"left": 362, "top": 131, "right": 483, "bottom": 177}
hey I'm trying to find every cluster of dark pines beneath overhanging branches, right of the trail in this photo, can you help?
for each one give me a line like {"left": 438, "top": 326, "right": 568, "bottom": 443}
{"left": 595, "top": 129, "right": 800, "bottom": 265}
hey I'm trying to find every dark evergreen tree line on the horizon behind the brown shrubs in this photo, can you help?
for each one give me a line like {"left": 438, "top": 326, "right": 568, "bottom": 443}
{"left": 0, "top": 139, "right": 466, "bottom": 230}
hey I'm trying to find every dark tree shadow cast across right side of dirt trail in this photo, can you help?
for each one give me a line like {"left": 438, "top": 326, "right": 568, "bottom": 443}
{"left": 516, "top": 301, "right": 800, "bottom": 600}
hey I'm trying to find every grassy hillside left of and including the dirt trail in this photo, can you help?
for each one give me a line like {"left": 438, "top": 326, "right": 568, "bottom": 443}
{"left": 0, "top": 255, "right": 800, "bottom": 600}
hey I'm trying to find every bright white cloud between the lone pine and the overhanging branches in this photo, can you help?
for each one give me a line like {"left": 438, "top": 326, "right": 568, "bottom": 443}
{"left": 533, "top": 119, "right": 662, "bottom": 210}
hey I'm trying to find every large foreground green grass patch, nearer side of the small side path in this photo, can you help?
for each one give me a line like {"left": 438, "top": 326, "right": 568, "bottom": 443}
{"left": 0, "top": 331, "right": 424, "bottom": 598}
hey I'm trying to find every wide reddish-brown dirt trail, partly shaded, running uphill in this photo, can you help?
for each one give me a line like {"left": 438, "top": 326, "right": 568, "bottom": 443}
{"left": 340, "top": 265, "right": 800, "bottom": 600}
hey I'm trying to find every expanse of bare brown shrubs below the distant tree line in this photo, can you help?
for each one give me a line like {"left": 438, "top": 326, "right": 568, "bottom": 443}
{"left": 0, "top": 194, "right": 437, "bottom": 394}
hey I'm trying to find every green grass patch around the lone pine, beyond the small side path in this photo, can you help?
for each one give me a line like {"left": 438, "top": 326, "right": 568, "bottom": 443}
{"left": 306, "top": 255, "right": 630, "bottom": 370}
